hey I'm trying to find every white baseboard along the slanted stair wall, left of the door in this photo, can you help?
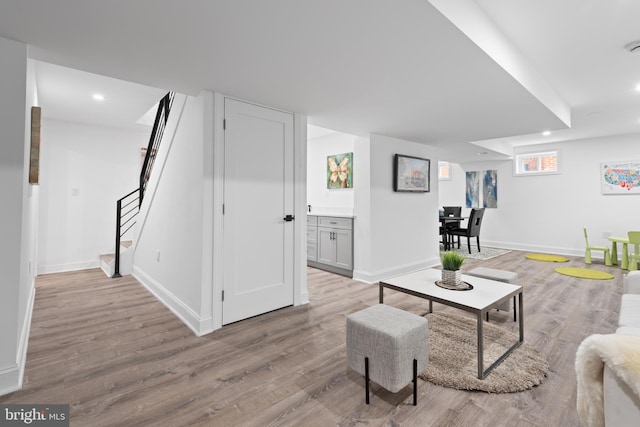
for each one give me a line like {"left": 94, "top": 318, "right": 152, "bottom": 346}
{"left": 133, "top": 266, "right": 214, "bottom": 336}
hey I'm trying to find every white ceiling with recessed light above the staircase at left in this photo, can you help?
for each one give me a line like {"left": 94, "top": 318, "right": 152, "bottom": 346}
{"left": 34, "top": 61, "right": 166, "bottom": 132}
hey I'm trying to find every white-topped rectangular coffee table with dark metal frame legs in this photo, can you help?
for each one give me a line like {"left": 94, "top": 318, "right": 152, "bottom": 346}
{"left": 380, "top": 268, "right": 524, "bottom": 380}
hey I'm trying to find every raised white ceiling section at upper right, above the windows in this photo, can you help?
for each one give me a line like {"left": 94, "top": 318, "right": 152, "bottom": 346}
{"left": 476, "top": 0, "right": 640, "bottom": 147}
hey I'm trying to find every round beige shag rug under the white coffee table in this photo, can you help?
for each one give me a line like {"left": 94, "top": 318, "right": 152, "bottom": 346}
{"left": 420, "top": 313, "right": 549, "bottom": 393}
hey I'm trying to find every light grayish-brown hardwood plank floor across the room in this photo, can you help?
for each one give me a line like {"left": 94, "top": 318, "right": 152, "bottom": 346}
{"left": 0, "top": 251, "right": 622, "bottom": 427}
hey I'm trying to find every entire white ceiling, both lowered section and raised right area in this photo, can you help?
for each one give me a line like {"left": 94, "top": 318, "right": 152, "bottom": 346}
{"left": 0, "top": 0, "right": 640, "bottom": 161}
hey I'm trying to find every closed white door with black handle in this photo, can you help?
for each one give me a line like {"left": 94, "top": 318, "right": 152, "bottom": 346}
{"left": 222, "top": 99, "right": 294, "bottom": 324}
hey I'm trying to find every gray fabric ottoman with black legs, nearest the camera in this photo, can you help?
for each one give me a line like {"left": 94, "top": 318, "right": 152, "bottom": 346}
{"left": 347, "top": 304, "right": 429, "bottom": 405}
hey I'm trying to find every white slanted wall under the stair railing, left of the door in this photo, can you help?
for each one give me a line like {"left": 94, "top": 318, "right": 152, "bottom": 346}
{"left": 134, "top": 92, "right": 213, "bottom": 335}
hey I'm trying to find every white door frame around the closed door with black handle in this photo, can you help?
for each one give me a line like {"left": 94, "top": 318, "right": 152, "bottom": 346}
{"left": 211, "top": 92, "right": 309, "bottom": 330}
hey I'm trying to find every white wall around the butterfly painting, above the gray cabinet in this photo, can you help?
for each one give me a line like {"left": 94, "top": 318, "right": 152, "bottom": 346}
{"left": 307, "top": 132, "right": 360, "bottom": 215}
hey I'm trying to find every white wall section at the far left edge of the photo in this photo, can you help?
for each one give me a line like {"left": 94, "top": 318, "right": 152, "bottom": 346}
{"left": 0, "top": 38, "right": 38, "bottom": 395}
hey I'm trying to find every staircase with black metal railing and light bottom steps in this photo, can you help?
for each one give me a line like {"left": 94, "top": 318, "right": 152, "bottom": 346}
{"left": 100, "top": 92, "right": 175, "bottom": 278}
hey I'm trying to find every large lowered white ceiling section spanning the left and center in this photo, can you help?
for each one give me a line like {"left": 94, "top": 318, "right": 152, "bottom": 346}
{"left": 0, "top": 0, "right": 566, "bottom": 160}
